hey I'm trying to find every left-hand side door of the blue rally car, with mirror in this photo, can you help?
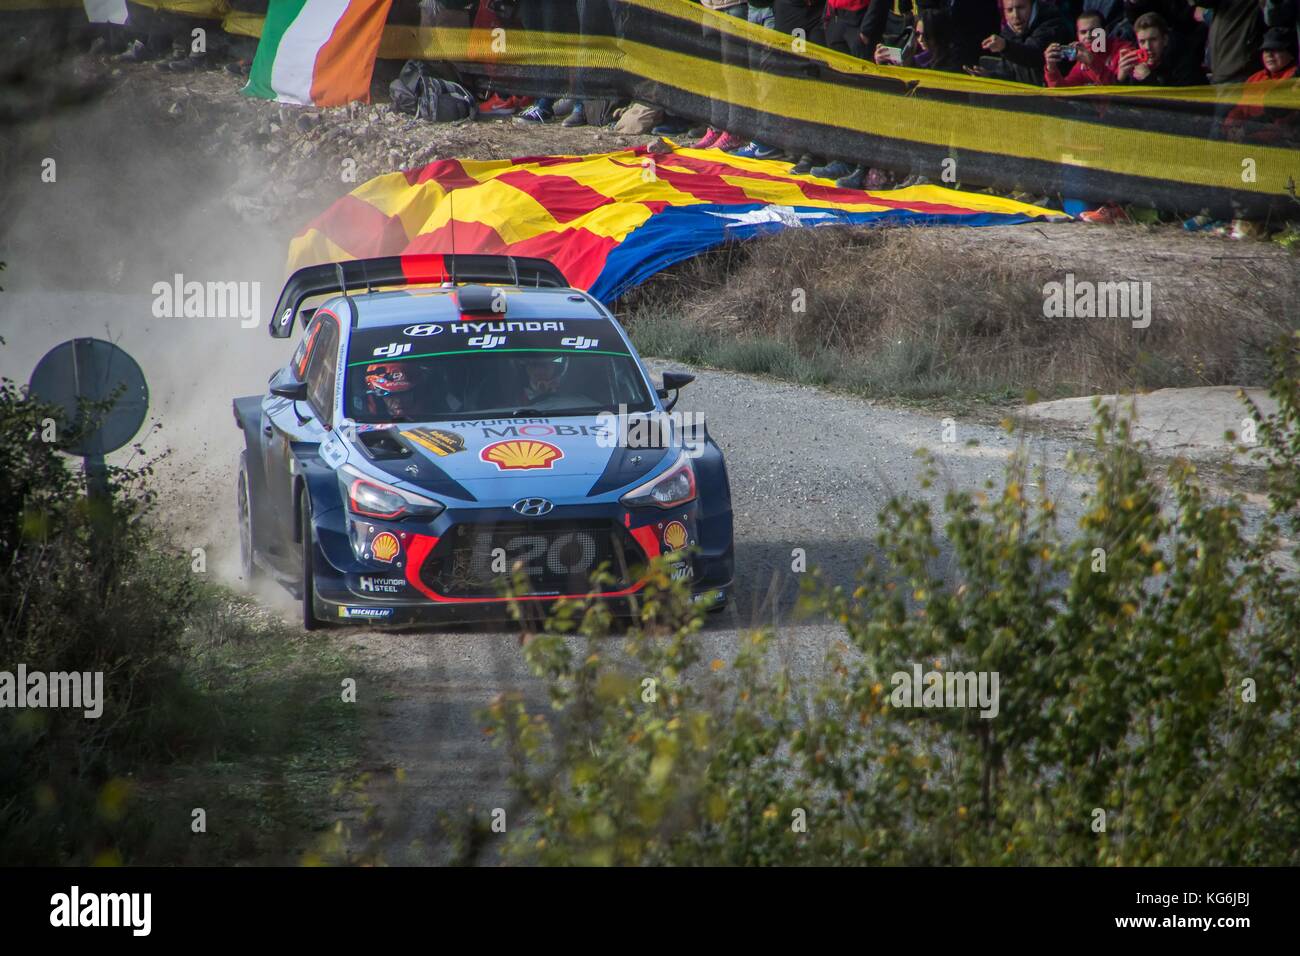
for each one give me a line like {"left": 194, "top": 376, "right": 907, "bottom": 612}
{"left": 263, "top": 312, "right": 338, "bottom": 556}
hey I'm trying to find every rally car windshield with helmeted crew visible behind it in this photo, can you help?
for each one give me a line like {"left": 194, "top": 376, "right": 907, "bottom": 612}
{"left": 343, "top": 325, "right": 654, "bottom": 424}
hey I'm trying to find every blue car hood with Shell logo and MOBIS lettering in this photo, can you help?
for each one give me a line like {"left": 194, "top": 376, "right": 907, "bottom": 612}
{"left": 345, "top": 412, "right": 673, "bottom": 505}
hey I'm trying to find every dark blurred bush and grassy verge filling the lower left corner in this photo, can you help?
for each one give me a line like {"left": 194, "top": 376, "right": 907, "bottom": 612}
{"left": 0, "top": 381, "right": 361, "bottom": 865}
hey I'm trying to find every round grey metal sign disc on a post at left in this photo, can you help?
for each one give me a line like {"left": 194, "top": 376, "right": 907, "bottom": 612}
{"left": 27, "top": 338, "right": 150, "bottom": 455}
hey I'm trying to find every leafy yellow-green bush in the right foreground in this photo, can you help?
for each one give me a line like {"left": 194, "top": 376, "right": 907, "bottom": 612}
{"left": 455, "top": 339, "right": 1300, "bottom": 865}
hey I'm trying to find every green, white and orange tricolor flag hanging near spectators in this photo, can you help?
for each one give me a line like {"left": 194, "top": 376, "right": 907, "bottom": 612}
{"left": 243, "top": 0, "right": 393, "bottom": 107}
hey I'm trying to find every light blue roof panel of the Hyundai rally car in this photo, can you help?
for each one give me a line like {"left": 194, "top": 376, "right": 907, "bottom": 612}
{"left": 351, "top": 286, "right": 610, "bottom": 329}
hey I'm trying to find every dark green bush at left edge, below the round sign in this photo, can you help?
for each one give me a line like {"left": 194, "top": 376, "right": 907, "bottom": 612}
{"left": 0, "top": 380, "right": 199, "bottom": 864}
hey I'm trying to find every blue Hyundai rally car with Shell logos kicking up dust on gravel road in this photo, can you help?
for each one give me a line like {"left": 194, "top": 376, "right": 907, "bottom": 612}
{"left": 234, "top": 255, "right": 733, "bottom": 628}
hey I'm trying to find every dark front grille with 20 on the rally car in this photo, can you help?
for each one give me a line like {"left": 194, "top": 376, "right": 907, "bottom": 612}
{"left": 420, "top": 520, "right": 646, "bottom": 597}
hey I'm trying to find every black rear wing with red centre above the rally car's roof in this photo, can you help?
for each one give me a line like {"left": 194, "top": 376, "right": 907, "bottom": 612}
{"left": 270, "top": 254, "right": 569, "bottom": 338}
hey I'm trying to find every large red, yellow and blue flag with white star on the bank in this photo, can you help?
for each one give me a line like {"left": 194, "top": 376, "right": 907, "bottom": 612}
{"left": 289, "top": 144, "right": 1061, "bottom": 302}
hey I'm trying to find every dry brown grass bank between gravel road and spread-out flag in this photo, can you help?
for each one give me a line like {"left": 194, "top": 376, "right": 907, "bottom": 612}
{"left": 620, "top": 228, "right": 1300, "bottom": 401}
